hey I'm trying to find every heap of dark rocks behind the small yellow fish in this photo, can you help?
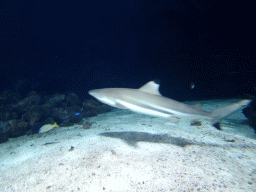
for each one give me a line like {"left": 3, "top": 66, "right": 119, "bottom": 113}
{"left": 0, "top": 90, "right": 111, "bottom": 142}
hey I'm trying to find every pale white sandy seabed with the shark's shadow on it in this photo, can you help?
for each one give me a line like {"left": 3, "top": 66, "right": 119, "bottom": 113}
{"left": 0, "top": 100, "right": 256, "bottom": 192}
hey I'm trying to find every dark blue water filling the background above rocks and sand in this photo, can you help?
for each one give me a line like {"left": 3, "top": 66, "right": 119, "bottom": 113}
{"left": 0, "top": 0, "right": 256, "bottom": 101}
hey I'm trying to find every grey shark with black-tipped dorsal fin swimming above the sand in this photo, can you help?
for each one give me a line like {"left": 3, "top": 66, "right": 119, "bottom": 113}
{"left": 89, "top": 81, "right": 251, "bottom": 125}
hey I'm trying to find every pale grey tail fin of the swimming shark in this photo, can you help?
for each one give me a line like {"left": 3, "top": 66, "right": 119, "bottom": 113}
{"left": 211, "top": 100, "right": 252, "bottom": 124}
